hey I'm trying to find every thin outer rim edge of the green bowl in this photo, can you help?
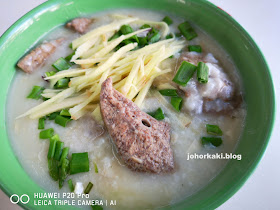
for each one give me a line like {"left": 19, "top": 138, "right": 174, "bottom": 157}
{"left": 0, "top": 0, "right": 276, "bottom": 209}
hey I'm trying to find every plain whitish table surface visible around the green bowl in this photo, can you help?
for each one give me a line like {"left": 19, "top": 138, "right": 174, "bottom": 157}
{"left": 0, "top": 0, "right": 280, "bottom": 210}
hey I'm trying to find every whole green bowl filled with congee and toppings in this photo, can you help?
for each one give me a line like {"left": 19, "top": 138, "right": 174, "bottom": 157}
{"left": 0, "top": 0, "right": 275, "bottom": 210}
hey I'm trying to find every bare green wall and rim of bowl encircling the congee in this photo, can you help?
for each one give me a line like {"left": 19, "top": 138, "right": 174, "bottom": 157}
{"left": 0, "top": 0, "right": 275, "bottom": 209}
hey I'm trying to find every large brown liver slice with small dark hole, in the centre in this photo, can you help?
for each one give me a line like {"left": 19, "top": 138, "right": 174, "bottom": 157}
{"left": 100, "top": 78, "right": 174, "bottom": 173}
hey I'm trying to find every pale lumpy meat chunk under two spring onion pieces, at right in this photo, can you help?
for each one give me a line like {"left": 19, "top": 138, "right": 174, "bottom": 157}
{"left": 180, "top": 52, "right": 240, "bottom": 114}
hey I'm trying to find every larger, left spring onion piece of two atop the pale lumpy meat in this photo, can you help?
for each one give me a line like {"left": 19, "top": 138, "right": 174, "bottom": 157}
{"left": 172, "top": 61, "right": 197, "bottom": 86}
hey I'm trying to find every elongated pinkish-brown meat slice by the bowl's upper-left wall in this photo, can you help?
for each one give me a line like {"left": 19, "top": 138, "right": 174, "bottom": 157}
{"left": 17, "top": 38, "right": 64, "bottom": 74}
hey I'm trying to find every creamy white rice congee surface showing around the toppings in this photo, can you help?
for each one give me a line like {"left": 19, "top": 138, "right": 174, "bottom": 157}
{"left": 7, "top": 10, "right": 246, "bottom": 209}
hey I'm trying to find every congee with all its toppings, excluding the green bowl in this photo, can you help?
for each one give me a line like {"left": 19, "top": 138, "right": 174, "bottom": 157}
{"left": 7, "top": 10, "right": 246, "bottom": 209}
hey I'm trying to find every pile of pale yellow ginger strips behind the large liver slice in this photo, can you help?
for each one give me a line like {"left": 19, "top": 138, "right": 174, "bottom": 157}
{"left": 19, "top": 15, "right": 186, "bottom": 122}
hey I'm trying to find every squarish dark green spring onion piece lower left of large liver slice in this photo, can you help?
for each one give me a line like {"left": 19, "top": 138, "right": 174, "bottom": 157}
{"left": 70, "top": 152, "right": 89, "bottom": 174}
